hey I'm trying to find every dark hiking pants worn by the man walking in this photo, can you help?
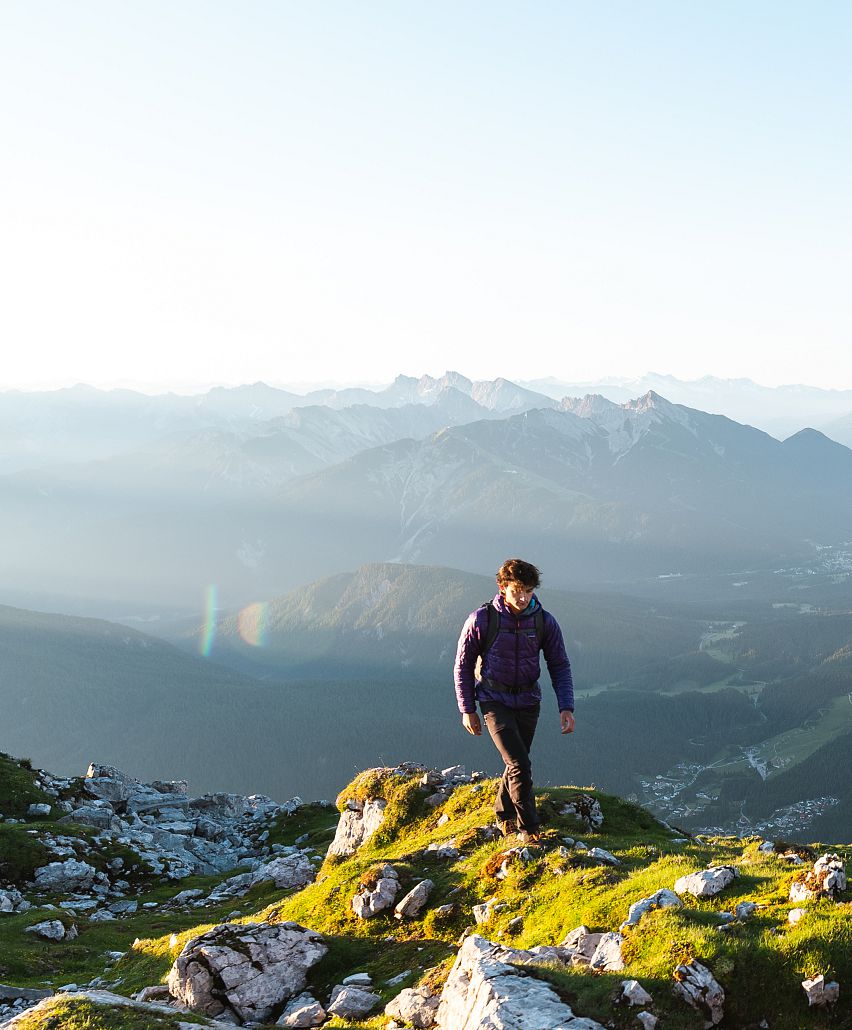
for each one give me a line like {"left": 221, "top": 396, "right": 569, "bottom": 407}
{"left": 480, "top": 700, "right": 539, "bottom": 833}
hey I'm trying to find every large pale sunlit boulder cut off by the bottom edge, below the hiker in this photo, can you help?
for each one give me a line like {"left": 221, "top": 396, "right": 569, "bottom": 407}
{"left": 436, "top": 934, "right": 604, "bottom": 1030}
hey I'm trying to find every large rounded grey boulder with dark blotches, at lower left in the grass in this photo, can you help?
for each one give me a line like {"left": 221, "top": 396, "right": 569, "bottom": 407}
{"left": 169, "top": 923, "right": 329, "bottom": 1023}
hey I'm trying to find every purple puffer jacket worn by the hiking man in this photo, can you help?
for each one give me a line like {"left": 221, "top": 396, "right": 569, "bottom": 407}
{"left": 453, "top": 593, "right": 574, "bottom": 714}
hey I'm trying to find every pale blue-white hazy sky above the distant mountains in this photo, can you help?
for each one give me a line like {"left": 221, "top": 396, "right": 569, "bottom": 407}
{"left": 0, "top": 0, "right": 852, "bottom": 388}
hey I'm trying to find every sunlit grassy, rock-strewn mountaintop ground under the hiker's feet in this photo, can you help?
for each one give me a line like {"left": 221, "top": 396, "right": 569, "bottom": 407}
{"left": 0, "top": 756, "right": 852, "bottom": 1030}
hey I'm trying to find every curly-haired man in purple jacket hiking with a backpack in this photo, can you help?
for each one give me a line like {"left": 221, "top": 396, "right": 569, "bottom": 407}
{"left": 453, "top": 558, "right": 574, "bottom": 844}
